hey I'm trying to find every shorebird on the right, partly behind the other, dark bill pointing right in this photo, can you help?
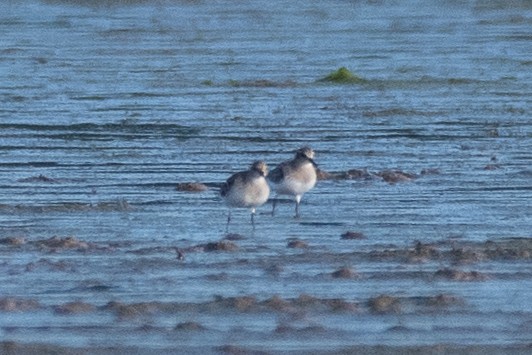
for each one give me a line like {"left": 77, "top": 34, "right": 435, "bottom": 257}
{"left": 268, "top": 147, "right": 318, "bottom": 218}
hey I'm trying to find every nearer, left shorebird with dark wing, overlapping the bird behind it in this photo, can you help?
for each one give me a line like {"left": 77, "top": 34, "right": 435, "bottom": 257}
{"left": 220, "top": 160, "right": 270, "bottom": 229}
